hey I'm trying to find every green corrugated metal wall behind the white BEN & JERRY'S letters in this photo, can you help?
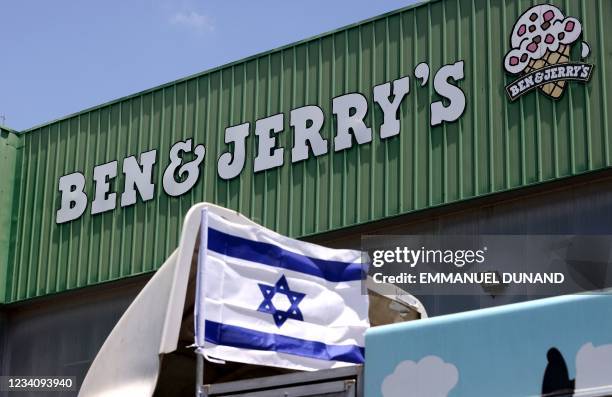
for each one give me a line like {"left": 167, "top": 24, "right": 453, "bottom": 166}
{"left": 6, "top": 0, "right": 612, "bottom": 302}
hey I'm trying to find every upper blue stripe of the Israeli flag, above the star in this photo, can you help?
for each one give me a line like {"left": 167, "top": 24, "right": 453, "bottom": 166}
{"left": 208, "top": 228, "right": 365, "bottom": 283}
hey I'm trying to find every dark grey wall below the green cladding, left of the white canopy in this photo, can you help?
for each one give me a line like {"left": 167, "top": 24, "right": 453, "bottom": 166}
{"left": 0, "top": 277, "right": 148, "bottom": 397}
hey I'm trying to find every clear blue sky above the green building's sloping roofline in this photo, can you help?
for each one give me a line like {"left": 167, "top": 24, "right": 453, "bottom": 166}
{"left": 0, "top": 0, "right": 414, "bottom": 130}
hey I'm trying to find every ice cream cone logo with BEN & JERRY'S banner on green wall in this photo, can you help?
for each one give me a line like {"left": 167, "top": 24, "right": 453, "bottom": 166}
{"left": 504, "top": 4, "right": 593, "bottom": 101}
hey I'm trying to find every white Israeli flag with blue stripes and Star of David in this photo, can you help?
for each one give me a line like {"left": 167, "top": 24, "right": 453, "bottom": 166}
{"left": 195, "top": 209, "right": 369, "bottom": 370}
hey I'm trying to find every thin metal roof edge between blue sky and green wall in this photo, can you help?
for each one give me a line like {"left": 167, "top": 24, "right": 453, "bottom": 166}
{"left": 21, "top": 0, "right": 432, "bottom": 134}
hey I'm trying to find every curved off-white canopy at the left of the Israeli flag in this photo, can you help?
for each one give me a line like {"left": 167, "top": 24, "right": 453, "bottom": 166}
{"left": 79, "top": 203, "right": 253, "bottom": 397}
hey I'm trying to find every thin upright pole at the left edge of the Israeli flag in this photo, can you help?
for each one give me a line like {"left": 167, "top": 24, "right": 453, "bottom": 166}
{"left": 194, "top": 207, "right": 208, "bottom": 397}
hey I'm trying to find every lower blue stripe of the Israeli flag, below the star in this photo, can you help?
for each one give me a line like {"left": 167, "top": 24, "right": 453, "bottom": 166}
{"left": 206, "top": 320, "right": 365, "bottom": 364}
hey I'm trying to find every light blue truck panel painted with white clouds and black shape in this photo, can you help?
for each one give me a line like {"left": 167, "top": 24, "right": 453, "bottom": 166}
{"left": 365, "top": 294, "right": 612, "bottom": 397}
